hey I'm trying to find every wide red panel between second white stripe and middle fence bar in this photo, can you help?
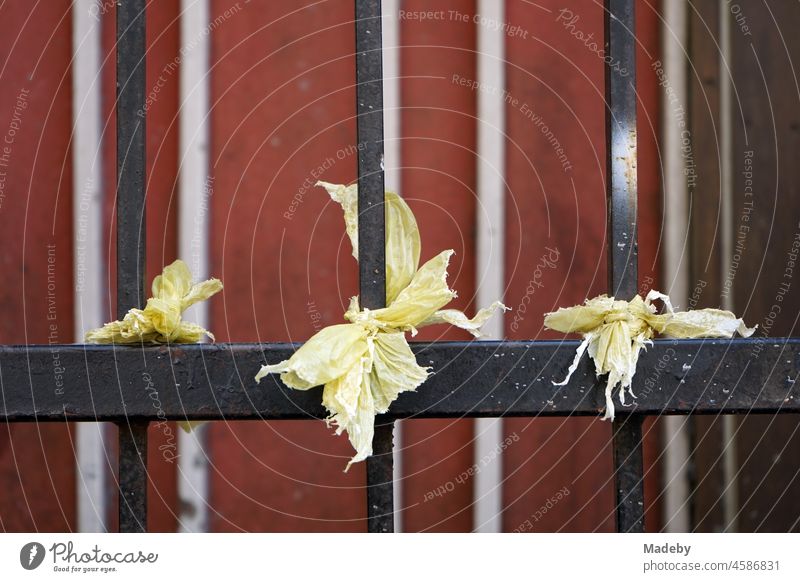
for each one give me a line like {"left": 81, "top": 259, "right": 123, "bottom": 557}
{"left": 210, "top": 0, "right": 366, "bottom": 531}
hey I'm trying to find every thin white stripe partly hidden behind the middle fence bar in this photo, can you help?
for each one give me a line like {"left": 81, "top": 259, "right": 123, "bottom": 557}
{"left": 381, "top": 0, "right": 403, "bottom": 532}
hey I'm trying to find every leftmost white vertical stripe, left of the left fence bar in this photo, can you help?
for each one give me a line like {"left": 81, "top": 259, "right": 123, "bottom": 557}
{"left": 72, "top": 0, "right": 108, "bottom": 532}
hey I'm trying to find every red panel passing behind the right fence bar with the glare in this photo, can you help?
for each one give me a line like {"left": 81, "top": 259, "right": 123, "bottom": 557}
{"left": 504, "top": 0, "right": 660, "bottom": 531}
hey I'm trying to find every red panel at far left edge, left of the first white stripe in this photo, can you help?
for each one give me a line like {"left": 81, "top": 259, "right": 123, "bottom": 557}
{"left": 0, "top": 0, "right": 75, "bottom": 531}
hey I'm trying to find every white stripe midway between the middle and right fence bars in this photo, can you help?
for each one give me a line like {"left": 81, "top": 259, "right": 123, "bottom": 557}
{"left": 473, "top": 0, "right": 505, "bottom": 533}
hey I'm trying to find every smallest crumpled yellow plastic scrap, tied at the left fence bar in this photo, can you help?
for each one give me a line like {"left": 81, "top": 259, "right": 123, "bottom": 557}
{"left": 86, "top": 260, "right": 222, "bottom": 344}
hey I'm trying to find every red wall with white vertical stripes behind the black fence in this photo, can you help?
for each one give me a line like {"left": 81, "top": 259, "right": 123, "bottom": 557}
{"left": 0, "top": 0, "right": 660, "bottom": 531}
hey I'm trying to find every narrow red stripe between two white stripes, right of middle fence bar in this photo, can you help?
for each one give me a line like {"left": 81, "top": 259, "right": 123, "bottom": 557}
{"left": 398, "top": 0, "right": 476, "bottom": 531}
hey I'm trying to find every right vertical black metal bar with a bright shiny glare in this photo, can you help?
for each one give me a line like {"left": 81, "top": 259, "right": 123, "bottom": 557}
{"left": 605, "top": 0, "right": 644, "bottom": 532}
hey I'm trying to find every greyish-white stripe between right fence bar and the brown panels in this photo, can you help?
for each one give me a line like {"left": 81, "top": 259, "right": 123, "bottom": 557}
{"left": 661, "top": 2, "right": 691, "bottom": 533}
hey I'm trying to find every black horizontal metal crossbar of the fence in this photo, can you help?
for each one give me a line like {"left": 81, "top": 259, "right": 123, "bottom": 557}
{"left": 0, "top": 338, "right": 800, "bottom": 422}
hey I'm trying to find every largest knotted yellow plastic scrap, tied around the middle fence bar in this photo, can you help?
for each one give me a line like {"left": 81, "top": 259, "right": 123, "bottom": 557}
{"left": 256, "top": 182, "right": 506, "bottom": 470}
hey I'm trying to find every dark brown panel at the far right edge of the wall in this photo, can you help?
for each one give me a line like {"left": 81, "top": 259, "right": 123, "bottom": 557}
{"left": 723, "top": 1, "right": 800, "bottom": 531}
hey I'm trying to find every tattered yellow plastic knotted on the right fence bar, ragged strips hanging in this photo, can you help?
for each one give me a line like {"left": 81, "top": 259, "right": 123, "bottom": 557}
{"left": 544, "top": 290, "right": 758, "bottom": 420}
